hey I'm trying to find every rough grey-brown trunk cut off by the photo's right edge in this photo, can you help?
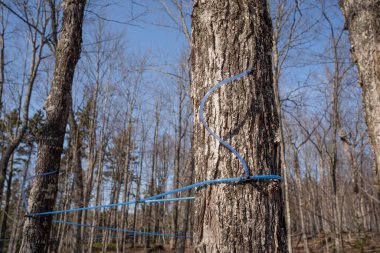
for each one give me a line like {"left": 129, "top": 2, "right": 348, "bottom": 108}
{"left": 340, "top": 0, "right": 380, "bottom": 191}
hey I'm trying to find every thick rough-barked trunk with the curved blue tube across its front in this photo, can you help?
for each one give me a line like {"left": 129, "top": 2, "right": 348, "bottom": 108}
{"left": 191, "top": 0, "right": 287, "bottom": 252}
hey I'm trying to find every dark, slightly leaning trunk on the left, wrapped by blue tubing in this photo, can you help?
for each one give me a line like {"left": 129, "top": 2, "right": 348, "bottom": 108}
{"left": 20, "top": 0, "right": 86, "bottom": 253}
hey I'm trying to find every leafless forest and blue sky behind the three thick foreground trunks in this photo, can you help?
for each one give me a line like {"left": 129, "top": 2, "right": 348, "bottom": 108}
{"left": 0, "top": 0, "right": 380, "bottom": 252}
